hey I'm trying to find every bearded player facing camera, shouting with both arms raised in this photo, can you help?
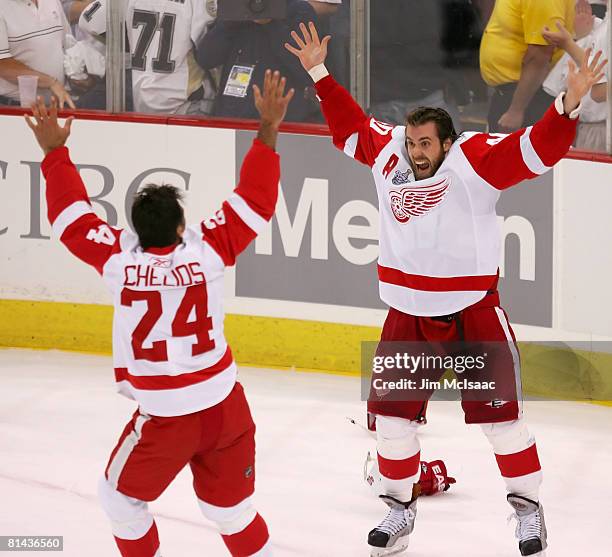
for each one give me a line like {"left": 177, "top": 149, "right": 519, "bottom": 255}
{"left": 285, "top": 23, "right": 606, "bottom": 556}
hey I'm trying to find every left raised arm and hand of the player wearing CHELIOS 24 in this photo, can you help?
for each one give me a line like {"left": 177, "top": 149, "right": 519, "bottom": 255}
{"left": 25, "top": 97, "right": 121, "bottom": 274}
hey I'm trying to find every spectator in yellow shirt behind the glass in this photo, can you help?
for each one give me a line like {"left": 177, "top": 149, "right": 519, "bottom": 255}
{"left": 480, "top": 0, "right": 575, "bottom": 133}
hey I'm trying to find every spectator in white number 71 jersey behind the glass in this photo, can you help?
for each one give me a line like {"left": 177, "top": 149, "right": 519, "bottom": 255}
{"left": 126, "top": 0, "right": 216, "bottom": 114}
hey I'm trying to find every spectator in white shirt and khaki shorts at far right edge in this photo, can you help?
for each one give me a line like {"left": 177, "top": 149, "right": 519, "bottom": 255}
{"left": 542, "top": 9, "right": 610, "bottom": 151}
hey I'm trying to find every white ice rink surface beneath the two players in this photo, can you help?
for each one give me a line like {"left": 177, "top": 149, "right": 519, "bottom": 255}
{"left": 0, "top": 350, "right": 612, "bottom": 557}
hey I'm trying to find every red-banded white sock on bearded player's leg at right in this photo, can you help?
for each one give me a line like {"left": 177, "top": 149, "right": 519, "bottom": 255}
{"left": 482, "top": 420, "right": 542, "bottom": 502}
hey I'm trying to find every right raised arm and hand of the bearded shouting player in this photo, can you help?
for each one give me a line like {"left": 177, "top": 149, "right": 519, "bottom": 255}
{"left": 461, "top": 49, "right": 607, "bottom": 189}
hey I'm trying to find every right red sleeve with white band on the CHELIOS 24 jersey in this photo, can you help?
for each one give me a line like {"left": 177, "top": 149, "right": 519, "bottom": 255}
{"left": 201, "top": 139, "right": 280, "bottom": 266}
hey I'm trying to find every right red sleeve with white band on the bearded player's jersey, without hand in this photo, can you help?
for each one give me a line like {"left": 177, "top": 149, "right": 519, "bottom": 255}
{"left": 461, "top": 93, "right": 579, "bottom": 190}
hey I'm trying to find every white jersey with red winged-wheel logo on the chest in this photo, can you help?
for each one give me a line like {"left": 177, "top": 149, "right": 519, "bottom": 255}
{"left": 316, "top": 72, "right": 577, "bottom": 316}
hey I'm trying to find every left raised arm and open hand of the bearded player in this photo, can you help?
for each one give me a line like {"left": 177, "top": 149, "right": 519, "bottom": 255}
{"left": 285, "top": 22, "right": 393, "bottom": 166}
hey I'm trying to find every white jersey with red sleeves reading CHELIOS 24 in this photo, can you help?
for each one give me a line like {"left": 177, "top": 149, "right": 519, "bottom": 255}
{"left": 42, "top": 140, "right": 280, "bottom": 416}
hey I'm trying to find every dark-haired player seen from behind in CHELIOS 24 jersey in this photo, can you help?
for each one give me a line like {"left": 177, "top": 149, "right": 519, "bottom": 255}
{"left": 26, "top": 70, "right": 294, "bottom": 557}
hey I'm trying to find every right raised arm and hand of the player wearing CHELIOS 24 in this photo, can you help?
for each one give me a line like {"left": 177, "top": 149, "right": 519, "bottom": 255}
{"left": 201, "top": 70, "right": 295, "bottom": 265}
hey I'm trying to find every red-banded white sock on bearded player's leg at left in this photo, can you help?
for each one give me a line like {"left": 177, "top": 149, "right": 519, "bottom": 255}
{"left": 376, "top": 416, "right": 421, "bottom": 502}
